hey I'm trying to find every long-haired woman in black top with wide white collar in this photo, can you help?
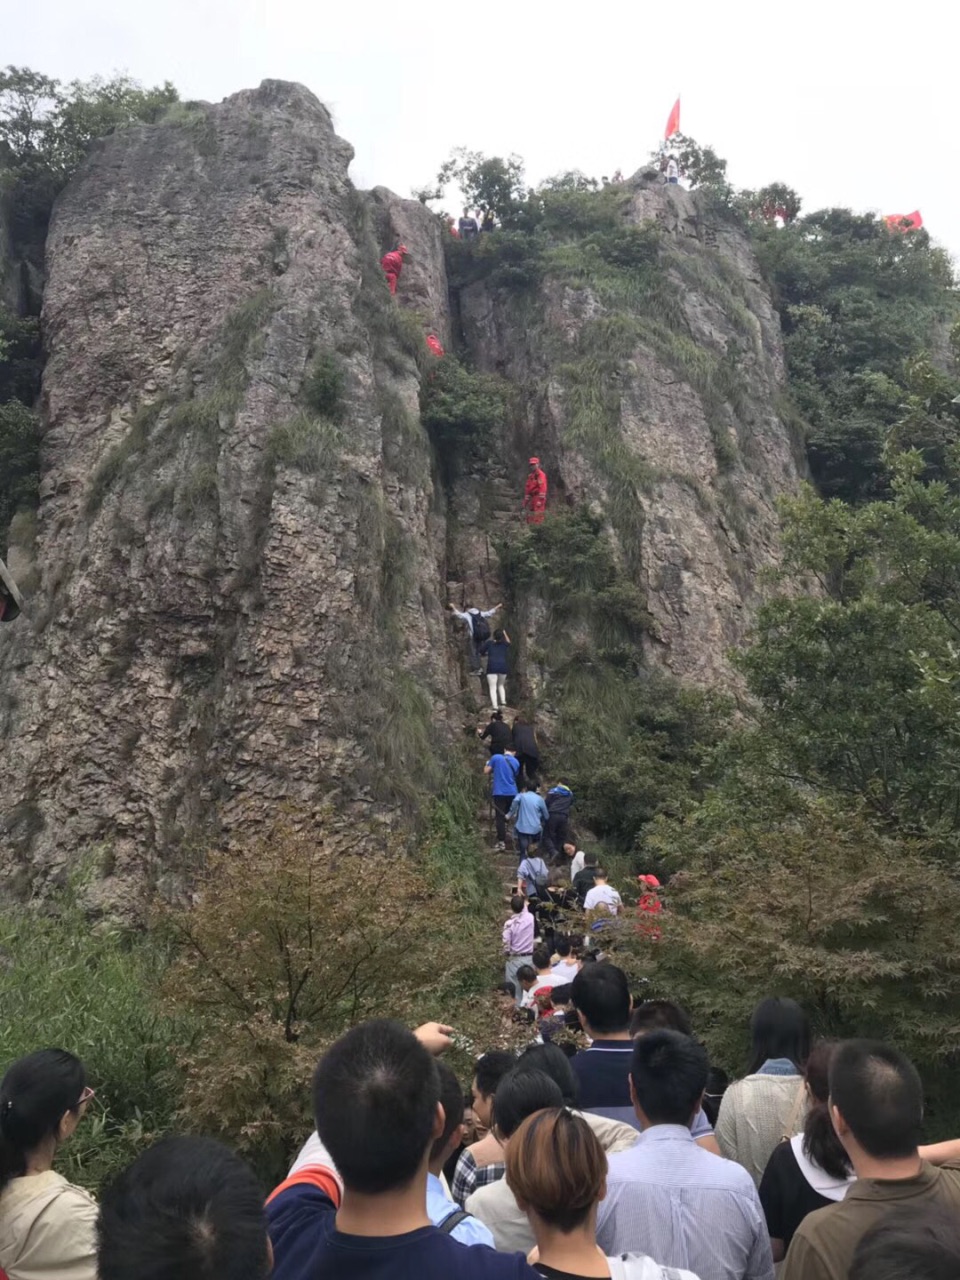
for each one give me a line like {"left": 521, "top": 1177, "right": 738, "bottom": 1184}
{"left": 760, "top": 1041, "right": 854, "bottom": 1262}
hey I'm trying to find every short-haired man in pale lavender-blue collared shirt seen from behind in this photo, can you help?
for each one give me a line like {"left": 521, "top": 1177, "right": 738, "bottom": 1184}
{"left": 601, "top": 1029, "right": 773, "bottom": 1280}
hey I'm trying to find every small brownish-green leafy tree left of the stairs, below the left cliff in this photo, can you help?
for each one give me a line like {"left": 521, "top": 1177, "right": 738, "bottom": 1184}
{"left": 164, "top": 820, "right": 493, "bottom": 1179}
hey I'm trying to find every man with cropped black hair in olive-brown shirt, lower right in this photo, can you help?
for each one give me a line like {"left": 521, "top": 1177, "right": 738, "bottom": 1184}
{"left": 782, "top": 1039, "right": 960, "bottom": 1280}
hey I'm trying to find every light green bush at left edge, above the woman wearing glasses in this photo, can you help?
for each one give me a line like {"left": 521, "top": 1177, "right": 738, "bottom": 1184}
{"left": 0, "top": 891, "right": 189, "bottom": 1192}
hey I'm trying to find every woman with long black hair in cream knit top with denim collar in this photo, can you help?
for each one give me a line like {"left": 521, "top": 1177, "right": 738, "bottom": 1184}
{"left": 717, "top": 996, "right": 810, "bottom": 1187}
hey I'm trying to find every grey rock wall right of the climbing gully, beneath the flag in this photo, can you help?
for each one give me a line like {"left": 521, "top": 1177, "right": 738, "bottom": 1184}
{"left": 453, "top": 175, "right": 804, "bottom": 685}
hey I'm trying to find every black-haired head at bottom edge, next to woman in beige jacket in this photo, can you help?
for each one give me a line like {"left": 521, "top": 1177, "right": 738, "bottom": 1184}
{"left": 97, "top": 1138, "right": 273, "bottom": 1280}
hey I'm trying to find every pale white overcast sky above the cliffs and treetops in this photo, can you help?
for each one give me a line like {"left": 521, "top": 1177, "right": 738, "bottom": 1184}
{"left": 9, "top": 0, "right": 960, "bottom": 257}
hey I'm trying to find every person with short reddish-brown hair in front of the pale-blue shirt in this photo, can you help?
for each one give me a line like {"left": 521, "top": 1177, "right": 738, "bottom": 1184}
{"left": 507, "top": 1107, "right": 695, "bottom": 1280}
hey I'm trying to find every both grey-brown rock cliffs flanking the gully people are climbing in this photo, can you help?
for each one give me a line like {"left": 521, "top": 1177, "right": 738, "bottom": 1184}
{"left": 0, "top": 81, "right": 797, "bottom": 901}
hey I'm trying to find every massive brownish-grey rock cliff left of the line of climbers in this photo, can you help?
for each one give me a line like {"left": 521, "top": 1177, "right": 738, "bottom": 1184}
{"left": 0, "top": 82, "right": 451, "bottom": 897}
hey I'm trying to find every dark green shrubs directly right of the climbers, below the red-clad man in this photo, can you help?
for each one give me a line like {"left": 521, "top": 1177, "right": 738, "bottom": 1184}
{"left": 498, "top": 508, "right": 726, "bottom": 855}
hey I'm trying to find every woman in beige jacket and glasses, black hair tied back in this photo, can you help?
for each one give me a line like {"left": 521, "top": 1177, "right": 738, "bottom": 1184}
{"left": 0, "top": 1048, "right": 97, "bottom": 1280}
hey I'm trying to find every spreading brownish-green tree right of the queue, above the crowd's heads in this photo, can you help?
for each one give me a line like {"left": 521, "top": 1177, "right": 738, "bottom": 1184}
{"left": 605, "top": 783, "right": 960, "bottom": 1138}
